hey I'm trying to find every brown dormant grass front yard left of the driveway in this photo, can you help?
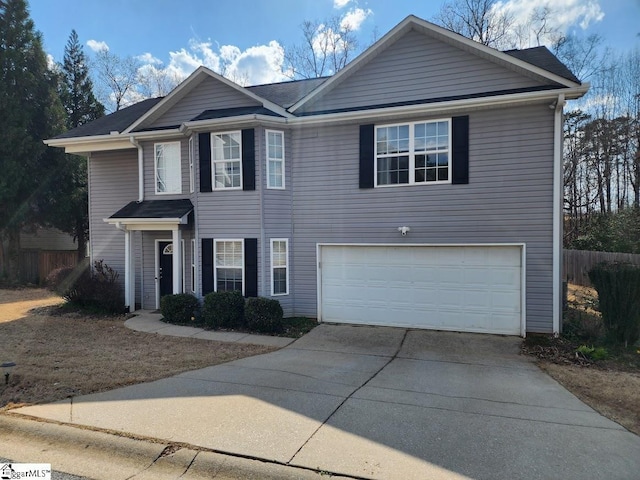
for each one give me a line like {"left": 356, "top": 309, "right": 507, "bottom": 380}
{"left": 0, "top": 289, "right": 276, "bottom": 410}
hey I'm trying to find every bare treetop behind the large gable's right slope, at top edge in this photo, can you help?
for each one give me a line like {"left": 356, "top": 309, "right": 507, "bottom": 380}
{"left": 434, "top": 0, "right": 515, "bottom": 49}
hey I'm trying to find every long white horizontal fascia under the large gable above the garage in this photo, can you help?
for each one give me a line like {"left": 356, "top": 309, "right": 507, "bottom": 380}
{"left": 289, "top": 84, "right": 589, "bottom": 125}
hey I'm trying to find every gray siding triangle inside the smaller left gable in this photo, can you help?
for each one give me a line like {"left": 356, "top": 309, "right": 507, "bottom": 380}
{"left": 149, "top": 78, "right": 261, "bottom": 127}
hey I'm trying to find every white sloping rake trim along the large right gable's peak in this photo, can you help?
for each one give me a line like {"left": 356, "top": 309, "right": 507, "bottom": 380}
{"left": 289, "top": 15, "right": 580, "bottom": 113}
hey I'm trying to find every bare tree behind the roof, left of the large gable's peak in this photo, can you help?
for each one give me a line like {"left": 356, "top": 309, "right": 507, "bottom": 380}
{"left": 285, "top": 16, "right": 358, "bottom": 78}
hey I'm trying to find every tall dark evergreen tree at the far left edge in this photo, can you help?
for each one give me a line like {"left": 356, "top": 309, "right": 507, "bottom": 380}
{"left": 0, "top": 0, "right": 64, "bottom": 281}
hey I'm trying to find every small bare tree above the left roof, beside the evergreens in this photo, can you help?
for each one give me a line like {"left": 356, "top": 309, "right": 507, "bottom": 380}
{"left": 94, "top": 48, "right": 140, "bottom": 111}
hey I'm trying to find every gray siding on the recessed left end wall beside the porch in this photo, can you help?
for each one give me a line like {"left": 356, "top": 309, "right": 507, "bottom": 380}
{"left": 89, "top": 150, "right": 140, "bottom": 297}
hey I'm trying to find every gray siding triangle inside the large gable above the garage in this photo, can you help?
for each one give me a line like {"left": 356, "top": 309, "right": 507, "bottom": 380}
{"left": 303, "top": 31, "right": 541, "bottom": 115}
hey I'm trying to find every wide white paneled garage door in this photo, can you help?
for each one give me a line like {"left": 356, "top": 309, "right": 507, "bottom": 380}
{"left": 318, "top": 245, "right": 523, "bottom": 335}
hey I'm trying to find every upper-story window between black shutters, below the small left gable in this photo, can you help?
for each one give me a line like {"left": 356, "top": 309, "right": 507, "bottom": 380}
{"left": 211, "top": 131, "right": 242, "bottom": 189}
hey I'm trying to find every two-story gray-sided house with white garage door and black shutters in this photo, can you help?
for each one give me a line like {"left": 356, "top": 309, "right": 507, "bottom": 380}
{"left": 46, "top": 16, "right": 588, "bottom": 335}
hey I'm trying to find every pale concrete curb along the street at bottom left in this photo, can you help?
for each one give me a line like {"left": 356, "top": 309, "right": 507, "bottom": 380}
{"left": 0, "top": 413, "right": 353, "bottom": 480}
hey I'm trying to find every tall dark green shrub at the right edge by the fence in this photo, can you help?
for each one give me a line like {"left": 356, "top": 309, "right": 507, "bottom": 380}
{"left": 589, "top": 263, "right": 640, "bottom": 346}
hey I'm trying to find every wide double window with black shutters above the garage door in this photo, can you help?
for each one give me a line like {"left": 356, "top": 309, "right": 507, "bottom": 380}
{"left": 375, "top": 119, "right": 451, "bottom": 186}
